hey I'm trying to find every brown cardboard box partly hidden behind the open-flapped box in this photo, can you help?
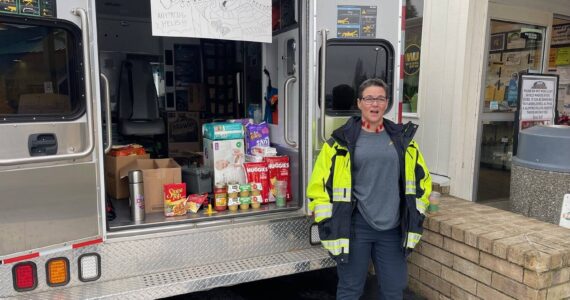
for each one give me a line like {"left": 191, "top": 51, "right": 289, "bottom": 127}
{"left": 105, "top": 154, "right": 150, "bottom": 199}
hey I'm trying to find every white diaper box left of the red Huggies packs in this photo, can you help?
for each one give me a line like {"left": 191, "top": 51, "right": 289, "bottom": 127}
{"left": 204, "top": 139, "right": 246, "bottom": 184}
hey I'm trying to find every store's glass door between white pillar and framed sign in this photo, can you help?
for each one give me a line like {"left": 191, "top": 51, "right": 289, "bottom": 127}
{"left": 476, "top": 20, "right": 546, "bottom": 202}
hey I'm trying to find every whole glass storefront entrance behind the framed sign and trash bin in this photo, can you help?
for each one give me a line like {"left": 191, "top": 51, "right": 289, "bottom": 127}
{"left": 474, "top": 3, "right": 570, "bottom": 207}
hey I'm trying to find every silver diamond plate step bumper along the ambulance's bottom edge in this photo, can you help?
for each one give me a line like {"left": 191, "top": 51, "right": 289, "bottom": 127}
{"left": 8, "top": 246, "right": 335, "bottom": 299}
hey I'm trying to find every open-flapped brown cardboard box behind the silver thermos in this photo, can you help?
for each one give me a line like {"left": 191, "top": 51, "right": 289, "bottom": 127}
{"left": 120, "top": 158, "right": 182, "bottom": 214}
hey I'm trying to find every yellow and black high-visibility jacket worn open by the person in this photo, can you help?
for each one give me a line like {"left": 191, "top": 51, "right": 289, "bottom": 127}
{"left": 307, "top": 117, "right": 432, "bottom": 263}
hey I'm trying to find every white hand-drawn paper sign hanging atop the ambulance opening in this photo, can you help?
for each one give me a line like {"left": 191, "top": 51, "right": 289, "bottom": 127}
{"left": 150, "top": 0, "right": 272, "bottom": 43}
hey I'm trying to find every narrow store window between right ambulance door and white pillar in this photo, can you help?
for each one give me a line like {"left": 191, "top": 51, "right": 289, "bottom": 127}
{"left": 402, "top": 0, "right": 424, "bottom": 114}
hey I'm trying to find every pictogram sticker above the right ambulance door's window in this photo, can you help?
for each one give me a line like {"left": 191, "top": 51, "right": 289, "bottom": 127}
{"left": 336, "top": 5, "right": 378, "bottom": 38}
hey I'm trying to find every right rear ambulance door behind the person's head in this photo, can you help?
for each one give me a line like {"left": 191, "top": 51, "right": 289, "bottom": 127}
{"left": 303, "top": 0, "right": 404, "bottom": 216}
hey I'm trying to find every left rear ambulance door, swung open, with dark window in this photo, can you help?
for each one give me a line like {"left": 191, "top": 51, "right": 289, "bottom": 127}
{"left": 0, "top": 1, "right": 104, "bottom": 263}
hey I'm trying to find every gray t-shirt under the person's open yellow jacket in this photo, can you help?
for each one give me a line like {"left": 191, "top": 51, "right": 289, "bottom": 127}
{"left": 353, "top": 130, "right": 400, "bottom": 230}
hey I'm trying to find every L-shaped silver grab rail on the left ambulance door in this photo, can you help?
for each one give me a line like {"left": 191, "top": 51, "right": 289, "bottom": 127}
{"left": 0, "top": 8, "right": 95, "bottom": 166}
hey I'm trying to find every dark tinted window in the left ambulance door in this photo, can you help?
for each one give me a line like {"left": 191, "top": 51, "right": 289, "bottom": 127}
{"left": 0, "top": 18, "right": 83, "bottom": 122}
